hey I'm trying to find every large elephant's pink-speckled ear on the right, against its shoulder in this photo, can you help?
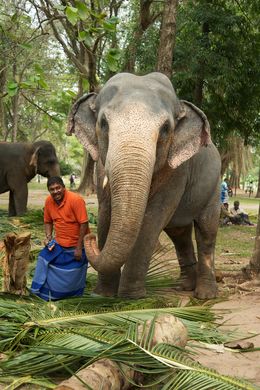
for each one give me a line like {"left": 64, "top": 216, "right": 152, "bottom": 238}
{"left": 168, "top": 100, "right": 211, "bottom": 169}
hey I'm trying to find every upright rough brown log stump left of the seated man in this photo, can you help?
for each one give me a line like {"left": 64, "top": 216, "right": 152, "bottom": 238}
{"left": 3, "top": 232, "right": 31, "bottom": 294}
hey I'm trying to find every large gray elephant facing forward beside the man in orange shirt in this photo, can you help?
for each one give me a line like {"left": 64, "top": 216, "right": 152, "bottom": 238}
{"left": 68, "top": 73, "right": 221, "bottom": 299}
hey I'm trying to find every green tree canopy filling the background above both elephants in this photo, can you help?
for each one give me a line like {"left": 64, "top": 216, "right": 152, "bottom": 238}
{"left": 0, "top": 0, "right": 260, "bottom": 174}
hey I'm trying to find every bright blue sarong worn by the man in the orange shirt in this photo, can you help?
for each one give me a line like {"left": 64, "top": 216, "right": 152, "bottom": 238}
{"left": 31, "top": 243, "right": 88, "bottom": 301}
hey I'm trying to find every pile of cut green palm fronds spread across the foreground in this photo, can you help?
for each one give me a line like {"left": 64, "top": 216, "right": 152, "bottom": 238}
{"left": 0, "top": 294, "right": 255, "bottom": 390}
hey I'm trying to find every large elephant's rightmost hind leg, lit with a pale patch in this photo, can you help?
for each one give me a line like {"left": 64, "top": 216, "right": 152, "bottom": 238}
{"left": 194, "top": 205, "right": 219, "bottom": 299}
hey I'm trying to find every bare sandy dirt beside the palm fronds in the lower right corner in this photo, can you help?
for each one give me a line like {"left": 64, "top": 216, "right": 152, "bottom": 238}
{"left": 198, "top": 290, "right": 260, "bottom": 388}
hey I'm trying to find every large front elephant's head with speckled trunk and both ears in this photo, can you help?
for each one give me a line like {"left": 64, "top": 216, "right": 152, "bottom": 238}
{"left": 68, "top": 73, "right": 210, "bottom": 274}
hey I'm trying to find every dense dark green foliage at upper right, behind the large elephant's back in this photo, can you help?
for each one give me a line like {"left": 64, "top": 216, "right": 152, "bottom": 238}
{"left": 173, "top": 1, "right": 260, "bottom": 147}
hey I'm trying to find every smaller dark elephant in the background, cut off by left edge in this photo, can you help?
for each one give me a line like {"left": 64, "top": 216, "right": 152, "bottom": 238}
{"left": 0, "top": 141, "right": 60, "bottom": 217}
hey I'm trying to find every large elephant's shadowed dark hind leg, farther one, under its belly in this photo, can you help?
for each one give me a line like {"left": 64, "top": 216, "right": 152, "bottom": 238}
{"left": 164, "top": 223, "right": 197, "bottom": 291}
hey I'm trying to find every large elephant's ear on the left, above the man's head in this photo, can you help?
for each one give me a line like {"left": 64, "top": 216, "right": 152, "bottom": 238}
{"left": 67, "top": 92, "right": 99, "bottom": 161}
